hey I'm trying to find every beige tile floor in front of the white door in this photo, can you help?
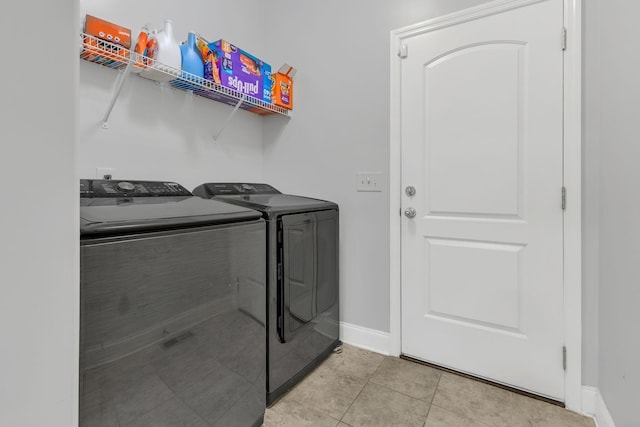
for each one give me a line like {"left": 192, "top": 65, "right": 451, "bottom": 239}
{"left": 264, "top": 345, "right": 595, "bottom": 427}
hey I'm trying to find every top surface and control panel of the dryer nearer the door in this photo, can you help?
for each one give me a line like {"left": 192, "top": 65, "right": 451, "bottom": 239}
{"left": 193, "top": 183, "right": 338, "bottom": 219}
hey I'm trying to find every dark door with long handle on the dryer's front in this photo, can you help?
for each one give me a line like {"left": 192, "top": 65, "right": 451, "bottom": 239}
{"left": 278, "top": 210, "right": 338, "bottom": 342}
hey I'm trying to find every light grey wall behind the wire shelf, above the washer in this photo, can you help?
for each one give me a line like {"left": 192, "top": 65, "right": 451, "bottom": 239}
{"left": 77, "top": 0, "right": 269, "bottom": 189}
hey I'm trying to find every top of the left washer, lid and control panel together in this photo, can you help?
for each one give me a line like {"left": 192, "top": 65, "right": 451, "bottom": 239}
{"left": 80, "top": 180, "right": 261, "bottom": 236}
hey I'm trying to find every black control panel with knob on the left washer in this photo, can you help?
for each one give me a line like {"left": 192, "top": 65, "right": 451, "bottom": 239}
{"left": 80, "top": 179, "right": 192, "bottom": 197}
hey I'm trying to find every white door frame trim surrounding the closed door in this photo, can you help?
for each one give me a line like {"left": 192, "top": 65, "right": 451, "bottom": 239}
{"left": 389, "top": 0, "right": 582, "bottom": 412}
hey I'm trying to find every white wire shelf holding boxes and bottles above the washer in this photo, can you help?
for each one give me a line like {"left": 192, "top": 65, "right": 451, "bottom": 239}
{"left": 80, "top": 33, "right": 290, "bottom": 116}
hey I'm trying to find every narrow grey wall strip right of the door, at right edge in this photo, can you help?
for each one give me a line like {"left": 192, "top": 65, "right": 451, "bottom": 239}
{"left": 596, "top": 0, "right": 640, "bottom": 427}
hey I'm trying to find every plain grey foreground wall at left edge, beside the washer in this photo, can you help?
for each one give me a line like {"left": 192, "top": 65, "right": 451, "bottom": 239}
{"left": 0, "top": 0, "right": 79, "bottom": 427}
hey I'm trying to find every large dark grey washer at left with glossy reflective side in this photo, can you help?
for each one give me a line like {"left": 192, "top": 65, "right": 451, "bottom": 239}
{"left": 80, "top": 180, "right": 266, "bottom": 427}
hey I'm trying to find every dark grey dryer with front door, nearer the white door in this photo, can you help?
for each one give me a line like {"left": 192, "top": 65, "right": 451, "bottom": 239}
{"left": 193, "top": 183, "right": 340, "bottom": 405}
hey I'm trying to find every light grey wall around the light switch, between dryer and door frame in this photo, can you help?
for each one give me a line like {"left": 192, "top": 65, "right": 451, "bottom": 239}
{"left": 265, "top": 0, "right": 498, "bottom": 332}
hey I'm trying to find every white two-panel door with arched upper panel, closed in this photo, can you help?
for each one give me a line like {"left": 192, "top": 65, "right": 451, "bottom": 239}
{"left": 401, "top": 0, "right": 564, "bottom": 400}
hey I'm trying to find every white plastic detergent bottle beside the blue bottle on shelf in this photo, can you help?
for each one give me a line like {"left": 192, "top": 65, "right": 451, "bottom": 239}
{"left": 140, "top": 19, "right": 182, "bottom": 82}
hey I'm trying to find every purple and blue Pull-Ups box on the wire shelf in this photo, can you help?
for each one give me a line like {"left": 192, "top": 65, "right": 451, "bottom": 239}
{"left": 209, "top": 39, "right": 271, "bottom": 104}
